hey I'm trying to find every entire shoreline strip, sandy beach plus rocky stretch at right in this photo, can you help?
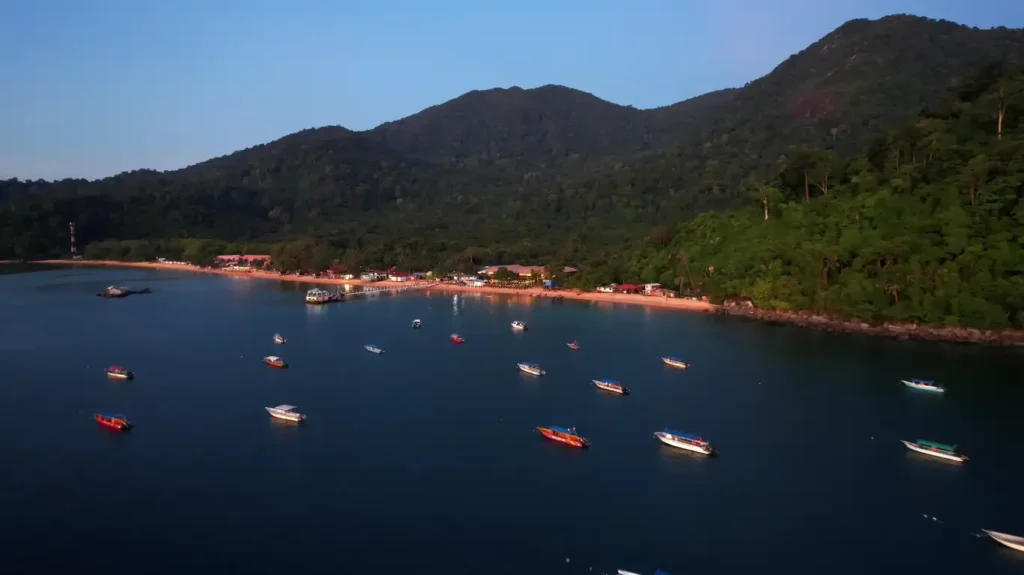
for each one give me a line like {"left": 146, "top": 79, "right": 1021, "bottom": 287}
{"left": 26, "top": 260, "right": 1024, "bottom": 347}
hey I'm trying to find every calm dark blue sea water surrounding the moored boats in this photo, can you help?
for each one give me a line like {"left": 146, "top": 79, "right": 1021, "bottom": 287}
{"left": 0, "top": 269, "right": 1024, "bottom": 575}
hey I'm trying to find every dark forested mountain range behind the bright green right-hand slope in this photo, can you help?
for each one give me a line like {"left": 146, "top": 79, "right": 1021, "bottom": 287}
{"left": 0, "top": 16, "right": 1024, "bottom": 267}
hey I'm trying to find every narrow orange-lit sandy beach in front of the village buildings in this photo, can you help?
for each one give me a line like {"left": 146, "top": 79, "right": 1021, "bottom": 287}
{"left": 34, "top": 260, "right": 718, "bottom": 312}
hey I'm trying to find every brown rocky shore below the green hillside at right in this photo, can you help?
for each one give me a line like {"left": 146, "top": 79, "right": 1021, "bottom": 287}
{"left": 718, "top": 301, "right": 1024, "bottom": 346}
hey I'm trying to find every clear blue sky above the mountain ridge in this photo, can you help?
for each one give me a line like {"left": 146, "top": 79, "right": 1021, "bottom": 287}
{"left": 0, "top": 0, "right": 1024, "bottom": 179}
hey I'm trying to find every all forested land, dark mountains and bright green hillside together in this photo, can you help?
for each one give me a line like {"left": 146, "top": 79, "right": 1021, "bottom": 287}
{"left": 0, "top": 16, "right": 1024, "bottom": 326}
